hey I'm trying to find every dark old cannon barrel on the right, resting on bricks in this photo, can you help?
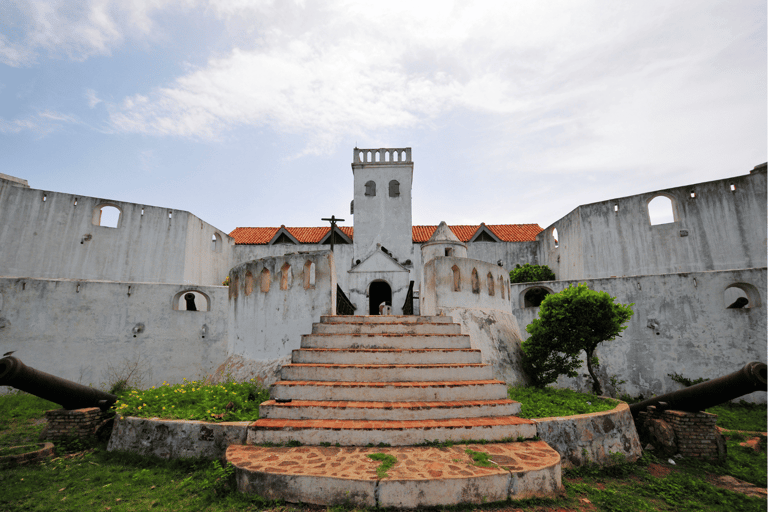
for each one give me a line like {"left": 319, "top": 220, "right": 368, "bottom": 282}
{"left": 629, "top": 361, "right": 766, "bottom": 417}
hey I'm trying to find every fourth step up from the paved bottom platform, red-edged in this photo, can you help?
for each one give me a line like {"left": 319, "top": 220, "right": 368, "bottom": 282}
{"left": 281, "top": 363, "right": 493, "bottom": 382}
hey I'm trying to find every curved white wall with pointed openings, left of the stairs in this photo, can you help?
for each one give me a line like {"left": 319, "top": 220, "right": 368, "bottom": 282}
{"left": 219, "top": 251, "right": 336, "bottom": 383}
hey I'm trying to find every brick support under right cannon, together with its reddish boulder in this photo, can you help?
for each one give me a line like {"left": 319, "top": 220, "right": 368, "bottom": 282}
{"left": 638, "top": 406, "right": 726, "bottom": 461}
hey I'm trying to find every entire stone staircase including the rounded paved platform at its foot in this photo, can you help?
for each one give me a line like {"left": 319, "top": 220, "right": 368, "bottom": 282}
{"left": 227, "top": 316, "right": 561, "bottom": 508}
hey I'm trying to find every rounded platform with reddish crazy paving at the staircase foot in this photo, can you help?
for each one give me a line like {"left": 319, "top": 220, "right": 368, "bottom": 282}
{"left": 227, "top": 441, "right": 560, "bottom": 508}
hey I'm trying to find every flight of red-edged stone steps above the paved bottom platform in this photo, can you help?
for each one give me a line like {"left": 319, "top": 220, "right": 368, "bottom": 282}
{"left": 248, "top": 316, "right": 536, "bottom": 446}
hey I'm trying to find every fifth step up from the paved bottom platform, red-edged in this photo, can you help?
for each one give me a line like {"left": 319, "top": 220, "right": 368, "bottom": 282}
{"left": 291, "top": 348, "right": 483, "bottom": 364}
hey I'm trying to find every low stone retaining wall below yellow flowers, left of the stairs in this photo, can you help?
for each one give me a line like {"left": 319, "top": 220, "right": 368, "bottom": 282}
{"left": 107, "top": 416, "right": 250, "bottom": 459}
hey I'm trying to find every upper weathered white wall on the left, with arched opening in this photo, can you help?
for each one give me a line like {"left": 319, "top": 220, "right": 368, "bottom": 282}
{"left": 0, "top": 180, "right": 234, "bottom": 286}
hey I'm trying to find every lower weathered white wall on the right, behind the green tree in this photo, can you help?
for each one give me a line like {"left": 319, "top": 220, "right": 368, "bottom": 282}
{"left": 511, "top": 268, "right": 766, "bottom": 402}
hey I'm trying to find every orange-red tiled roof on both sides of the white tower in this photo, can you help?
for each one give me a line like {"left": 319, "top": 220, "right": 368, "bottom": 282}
{"left": 229, "top": 224, "right": 543, "bottom": 245}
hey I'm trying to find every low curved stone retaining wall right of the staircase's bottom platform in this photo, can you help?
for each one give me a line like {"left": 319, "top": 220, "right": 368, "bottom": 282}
{"left": 534, "top": 402, "right": 642, "bottom": 468}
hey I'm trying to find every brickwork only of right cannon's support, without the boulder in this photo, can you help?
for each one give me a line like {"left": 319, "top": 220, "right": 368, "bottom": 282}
{"left": 639, "top": 406, "right": 719, "bottom": 459}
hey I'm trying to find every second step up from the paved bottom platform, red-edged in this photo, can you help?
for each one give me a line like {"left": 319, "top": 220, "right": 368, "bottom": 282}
{"left": 259, "top": 399, "right": 521, "bottom": 420}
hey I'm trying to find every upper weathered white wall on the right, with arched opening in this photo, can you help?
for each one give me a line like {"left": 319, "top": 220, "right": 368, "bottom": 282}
{"left": 537, "top": 166, "right": 768, "bottom": 280}
